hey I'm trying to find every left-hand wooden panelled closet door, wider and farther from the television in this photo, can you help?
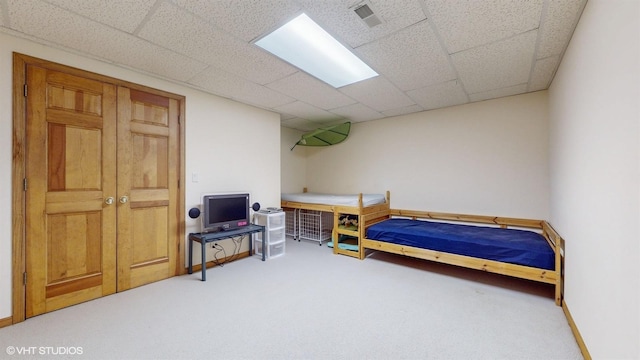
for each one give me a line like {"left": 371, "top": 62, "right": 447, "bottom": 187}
{"left": 25, "top": 65, "right": 116, "bottom": 317}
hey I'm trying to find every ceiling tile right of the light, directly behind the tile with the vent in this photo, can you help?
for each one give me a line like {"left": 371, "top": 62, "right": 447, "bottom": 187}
{"left": 356, "top": 21, "right": 456, "bottom": 91}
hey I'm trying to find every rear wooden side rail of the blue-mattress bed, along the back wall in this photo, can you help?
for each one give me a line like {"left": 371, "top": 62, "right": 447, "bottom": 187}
{"left": 390, "top": 209, "right": 544, "bottom": 229}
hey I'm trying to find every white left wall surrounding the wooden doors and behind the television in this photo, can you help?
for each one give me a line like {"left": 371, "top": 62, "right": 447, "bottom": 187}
{"left": 0, "top": 33, "right": 281, "bottom": 319}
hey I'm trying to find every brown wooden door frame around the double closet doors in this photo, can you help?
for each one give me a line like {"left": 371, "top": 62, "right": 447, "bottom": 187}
{"left": 11, "top": 52, "right": 186, "bottom": 324}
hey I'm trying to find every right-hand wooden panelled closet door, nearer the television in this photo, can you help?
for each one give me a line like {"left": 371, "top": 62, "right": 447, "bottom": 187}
{"left": 118, "top": 87, "right": 180, "bottom": 291}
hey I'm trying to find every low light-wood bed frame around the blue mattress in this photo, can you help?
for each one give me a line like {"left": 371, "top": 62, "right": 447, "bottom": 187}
{"left": 359, "top": 209, "right": 564, "bottom": 306}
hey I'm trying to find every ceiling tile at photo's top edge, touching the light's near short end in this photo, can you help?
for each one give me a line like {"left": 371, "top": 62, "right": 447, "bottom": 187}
{"left": 174, "top": 0, "right": 300, "bottom": 42}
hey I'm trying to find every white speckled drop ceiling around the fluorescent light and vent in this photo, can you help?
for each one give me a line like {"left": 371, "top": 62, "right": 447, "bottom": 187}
{"left": 0, "top": 0, "right": 586, "bottom": 130}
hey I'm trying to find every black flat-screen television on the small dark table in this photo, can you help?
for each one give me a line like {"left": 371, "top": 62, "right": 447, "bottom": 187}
{"left": 202, "top": 194, "right": 250, "bottom": 233}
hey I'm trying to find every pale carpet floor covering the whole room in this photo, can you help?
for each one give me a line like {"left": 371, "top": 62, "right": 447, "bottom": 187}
{"left": 0, "top": 239, "right": 582, "bottom": 360}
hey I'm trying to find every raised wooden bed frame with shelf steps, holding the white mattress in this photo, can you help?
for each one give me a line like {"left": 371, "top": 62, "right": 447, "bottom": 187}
{"left": 280, "top": 188, "right": 390, "bottom": 259}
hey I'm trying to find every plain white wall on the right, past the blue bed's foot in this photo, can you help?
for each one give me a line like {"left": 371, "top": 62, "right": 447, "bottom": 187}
{"left": 549, "top": 0, "right": 640, "bottom": 359}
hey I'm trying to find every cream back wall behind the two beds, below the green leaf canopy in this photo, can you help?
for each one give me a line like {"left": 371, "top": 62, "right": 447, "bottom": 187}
{"left": 296, "top": 91, "right": 549, "bottom": 219}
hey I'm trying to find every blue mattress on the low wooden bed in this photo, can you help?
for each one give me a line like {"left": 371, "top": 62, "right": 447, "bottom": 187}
{"left": 366, "top": 219, "right": 555, "bottom": 270}
